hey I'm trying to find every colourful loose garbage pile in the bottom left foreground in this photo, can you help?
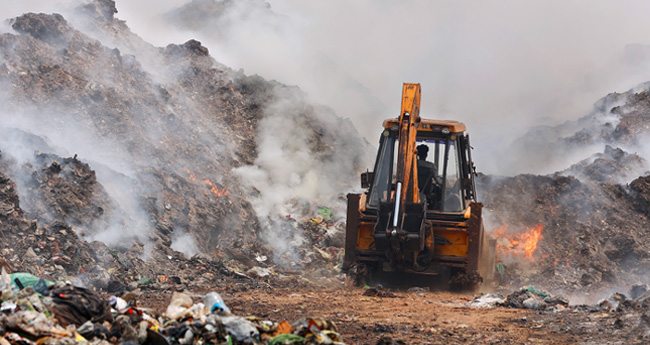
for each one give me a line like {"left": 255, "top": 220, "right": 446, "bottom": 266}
{"left": 0, "top": 269, "right": 344, "bottom": 345}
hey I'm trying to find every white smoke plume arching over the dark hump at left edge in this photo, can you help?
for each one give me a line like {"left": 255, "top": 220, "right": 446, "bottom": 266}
{"left": 0, "top": 107, "right": 151, "bottom": 251}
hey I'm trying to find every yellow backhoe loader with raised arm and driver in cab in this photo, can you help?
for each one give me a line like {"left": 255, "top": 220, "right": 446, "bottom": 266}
{"left": 343, "top": 84, "right": 496, "bottom": 287}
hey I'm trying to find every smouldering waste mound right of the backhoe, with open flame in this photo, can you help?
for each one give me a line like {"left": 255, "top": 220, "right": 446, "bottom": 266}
{"left": 477, "top": 80, "right": 650, "bottom": 293}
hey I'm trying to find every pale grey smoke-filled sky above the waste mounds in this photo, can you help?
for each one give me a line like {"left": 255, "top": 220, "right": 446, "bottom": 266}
{"left": 0, "top": 0, "right": 650, "bottom": 172}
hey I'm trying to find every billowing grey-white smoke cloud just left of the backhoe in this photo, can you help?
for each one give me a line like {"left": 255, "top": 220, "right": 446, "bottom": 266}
{"left": 235, "top": 88, "right": 370, "bottom": 264}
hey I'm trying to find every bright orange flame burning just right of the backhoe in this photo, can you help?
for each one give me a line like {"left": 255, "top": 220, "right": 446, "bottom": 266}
{"left": 493, "top": 224, "right": 544, "bottom": 261}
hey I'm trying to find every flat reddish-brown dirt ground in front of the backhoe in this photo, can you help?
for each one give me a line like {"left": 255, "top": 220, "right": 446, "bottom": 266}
{"left": 229, "top": 288, "right": 650, "bottom": 345}
